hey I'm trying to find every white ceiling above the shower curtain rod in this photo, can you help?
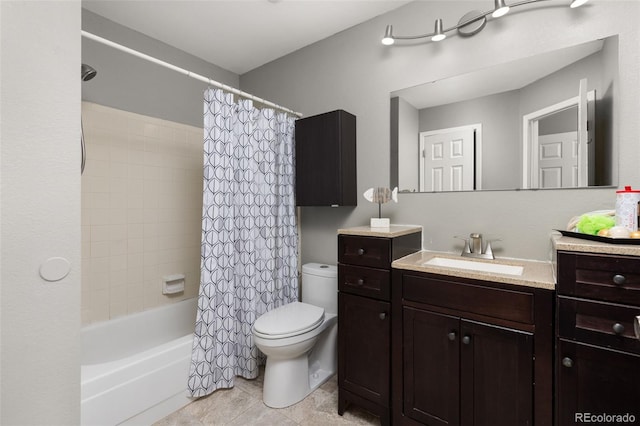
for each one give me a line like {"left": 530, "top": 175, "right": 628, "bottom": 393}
{"left": 82, "top": 0, "right": 409, "bottom": 75}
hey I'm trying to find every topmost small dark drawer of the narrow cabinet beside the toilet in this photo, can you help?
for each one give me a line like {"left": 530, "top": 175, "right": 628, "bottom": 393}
{"left": 338, "top": 235, "right": 392, "bottom": 268}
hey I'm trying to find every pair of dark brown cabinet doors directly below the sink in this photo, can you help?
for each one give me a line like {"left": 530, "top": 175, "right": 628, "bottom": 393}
{"left": 403, "top": 307, "right": 534, "bottom": 426}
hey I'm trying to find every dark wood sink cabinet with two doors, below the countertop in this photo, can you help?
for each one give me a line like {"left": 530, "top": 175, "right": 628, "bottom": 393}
{"left": 392, "top": 270, "right": 553, "bottom": 426}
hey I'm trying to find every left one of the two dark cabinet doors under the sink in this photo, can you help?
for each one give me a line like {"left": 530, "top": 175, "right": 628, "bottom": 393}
{"left": 403, "top": 307, "right": 460, "bottom": 426}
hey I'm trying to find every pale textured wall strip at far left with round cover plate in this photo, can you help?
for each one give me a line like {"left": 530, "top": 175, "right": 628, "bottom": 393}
{"left": 0, "top": 1, "right": 80, "bottom": 426}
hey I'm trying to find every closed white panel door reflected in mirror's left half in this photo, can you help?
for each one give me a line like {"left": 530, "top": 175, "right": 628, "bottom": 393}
{"left": 420, "top": 126, "right": 475, "bottom": 192}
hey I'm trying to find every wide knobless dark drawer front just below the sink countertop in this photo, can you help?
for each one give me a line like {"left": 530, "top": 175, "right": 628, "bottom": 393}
{"left": 402, "top": 274, "right": 534, "bottom": 324}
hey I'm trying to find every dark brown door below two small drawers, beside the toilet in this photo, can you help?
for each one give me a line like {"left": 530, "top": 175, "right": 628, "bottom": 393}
{"left": 338, "top": 293, "right": 391, "bottom": 407}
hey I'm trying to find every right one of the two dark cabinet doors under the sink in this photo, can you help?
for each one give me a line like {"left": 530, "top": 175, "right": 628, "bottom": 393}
{"left": 460, "top": 319, "right": 533, "bottom": 426}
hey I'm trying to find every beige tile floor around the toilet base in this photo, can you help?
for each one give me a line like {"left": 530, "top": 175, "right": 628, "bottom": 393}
{"left": 154, "top": 373, "right": 380, "bottom": 426}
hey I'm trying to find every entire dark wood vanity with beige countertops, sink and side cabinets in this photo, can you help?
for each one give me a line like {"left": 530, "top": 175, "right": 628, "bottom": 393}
{"left": 338, "top": 227, "right": 640, "bottom": 426}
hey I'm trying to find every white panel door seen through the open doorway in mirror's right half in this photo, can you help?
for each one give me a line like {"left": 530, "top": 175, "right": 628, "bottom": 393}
{"left": 537, "top": 132, "right": 579, "bottom": 188}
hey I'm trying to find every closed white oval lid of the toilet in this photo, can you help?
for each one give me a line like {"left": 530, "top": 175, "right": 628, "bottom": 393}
{"left": 253, "top": 302, "right": 324, "bottom": 338}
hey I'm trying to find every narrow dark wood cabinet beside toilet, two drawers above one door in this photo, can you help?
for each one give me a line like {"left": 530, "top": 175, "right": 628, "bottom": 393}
{"left": 338, "top": 228, "right": 422, "bottom": 425}
